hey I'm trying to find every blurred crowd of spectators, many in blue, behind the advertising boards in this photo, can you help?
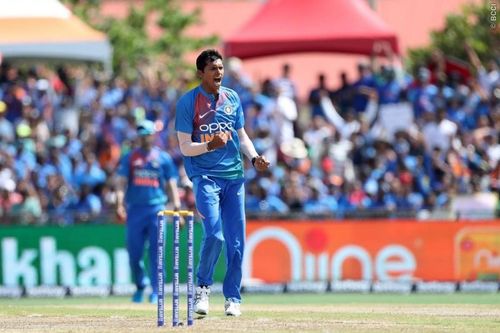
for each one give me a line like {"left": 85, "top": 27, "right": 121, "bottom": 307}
{"left": 0, "top": 50, "right": 500, "bottom": 225}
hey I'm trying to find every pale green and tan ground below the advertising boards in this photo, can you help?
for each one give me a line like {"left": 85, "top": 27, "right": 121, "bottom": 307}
{"left": 0, "top": 293, "right": 500, "bottom": 333}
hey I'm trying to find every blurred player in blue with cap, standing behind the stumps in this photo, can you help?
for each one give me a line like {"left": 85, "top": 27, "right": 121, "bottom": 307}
{"left": 117, "top": 120, "right": 180, "bottom": 303}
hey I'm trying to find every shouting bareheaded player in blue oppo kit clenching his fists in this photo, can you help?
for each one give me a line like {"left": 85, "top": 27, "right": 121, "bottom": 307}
{"left": 175, "top": 50, "right": 269, "bottom": 316}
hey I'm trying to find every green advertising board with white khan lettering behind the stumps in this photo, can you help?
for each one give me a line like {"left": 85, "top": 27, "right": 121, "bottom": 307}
{"left": 0, "top": 223, "right": 224, "bottom": 287}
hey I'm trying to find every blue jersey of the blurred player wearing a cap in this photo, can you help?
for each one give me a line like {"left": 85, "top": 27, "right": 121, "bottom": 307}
{"left": 118, "top": 147, "right": 178, "bottom": 206}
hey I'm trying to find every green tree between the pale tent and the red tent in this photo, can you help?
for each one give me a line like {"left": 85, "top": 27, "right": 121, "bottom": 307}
{"left": 64, "top": 0, "right": 218, "bottom": 80}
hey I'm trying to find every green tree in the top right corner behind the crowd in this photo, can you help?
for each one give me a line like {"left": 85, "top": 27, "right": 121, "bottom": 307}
{"left": 408, "top": 1, "right": 500, "bottom": 74}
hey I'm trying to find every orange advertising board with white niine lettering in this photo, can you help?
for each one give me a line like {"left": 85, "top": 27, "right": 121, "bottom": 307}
{"left": 243, "top": 220, "right": 500, "bottom": 283}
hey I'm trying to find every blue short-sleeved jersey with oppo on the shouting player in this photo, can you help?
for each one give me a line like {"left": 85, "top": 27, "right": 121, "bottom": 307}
{"left": 175, "top": 85, "right": 244, "bottom": 179}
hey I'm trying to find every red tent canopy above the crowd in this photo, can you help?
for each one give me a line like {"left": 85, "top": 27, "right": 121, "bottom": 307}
{"left": 224, "top": 0, "right": 399, "bottom": 59}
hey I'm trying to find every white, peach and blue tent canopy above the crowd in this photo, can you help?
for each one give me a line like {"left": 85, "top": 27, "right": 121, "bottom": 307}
{"left": 0, "top": 0, "right": 112, "bottom": 69}
